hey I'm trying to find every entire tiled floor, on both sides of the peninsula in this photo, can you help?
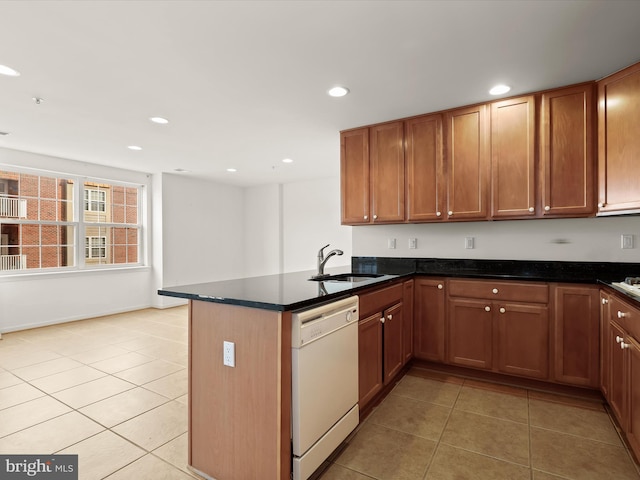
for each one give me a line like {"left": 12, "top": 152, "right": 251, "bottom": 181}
{"left": 0, "top": 307, "right": 640, "bottom": 480}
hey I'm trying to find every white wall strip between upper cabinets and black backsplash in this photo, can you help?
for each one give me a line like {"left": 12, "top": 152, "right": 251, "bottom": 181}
{"left": 353, "top": 216, "right": 640, "bottom": 263}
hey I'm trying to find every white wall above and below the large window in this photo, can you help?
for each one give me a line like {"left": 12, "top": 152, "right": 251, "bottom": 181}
{"left": 0, "top": 148, "right": 153, "bottom": 332}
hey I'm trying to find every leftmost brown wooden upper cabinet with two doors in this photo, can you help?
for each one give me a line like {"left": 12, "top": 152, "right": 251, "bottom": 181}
{"left": 340, "top": 121, "right": 405, "bottom": 225}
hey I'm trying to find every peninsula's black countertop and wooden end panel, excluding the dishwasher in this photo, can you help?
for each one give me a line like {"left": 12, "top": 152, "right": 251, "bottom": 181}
{"left": 158, "top": 267, "right": 397, "bottom": 480}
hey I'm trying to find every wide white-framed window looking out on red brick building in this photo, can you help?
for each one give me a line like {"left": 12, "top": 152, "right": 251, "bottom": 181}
{"left": 0, "top": 167, "right": 144, "bottom": 275}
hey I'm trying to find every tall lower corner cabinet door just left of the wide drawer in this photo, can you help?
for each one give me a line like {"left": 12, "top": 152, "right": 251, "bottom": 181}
{"left": 413, "top": 278, "right": 445, "bottom": 362}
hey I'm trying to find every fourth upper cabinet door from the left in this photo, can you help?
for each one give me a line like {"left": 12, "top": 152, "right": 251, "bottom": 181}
{"left": 445, "top": 105, "right": 489, "bottom": 220}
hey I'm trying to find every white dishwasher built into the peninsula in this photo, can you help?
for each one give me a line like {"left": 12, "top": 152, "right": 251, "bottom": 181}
{"left": 291, "top": 296, "right": 359, "bottom": 480}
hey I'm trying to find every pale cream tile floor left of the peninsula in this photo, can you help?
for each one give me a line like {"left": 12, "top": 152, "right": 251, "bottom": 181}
{"left": 0, "top": 307, "right": 199, "bottom": 480}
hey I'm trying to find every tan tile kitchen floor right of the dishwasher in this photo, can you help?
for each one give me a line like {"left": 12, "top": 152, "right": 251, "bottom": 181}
{"left": 321, "top": 368, "right": 640, "bottom": 480}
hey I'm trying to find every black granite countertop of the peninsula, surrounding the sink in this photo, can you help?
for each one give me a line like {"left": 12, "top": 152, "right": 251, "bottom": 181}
{"left": 158, "top": 267, "right": 402, "bottom": 311}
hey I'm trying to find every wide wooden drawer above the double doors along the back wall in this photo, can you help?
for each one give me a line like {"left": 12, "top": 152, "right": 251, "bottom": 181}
{"left": 448, "top": 279, "right": 549, "bottom": 303}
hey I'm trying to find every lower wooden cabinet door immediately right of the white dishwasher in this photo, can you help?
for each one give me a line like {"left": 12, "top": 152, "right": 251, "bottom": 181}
{"left": 358, "top": 313, "right": 382, "bottom": 410}
